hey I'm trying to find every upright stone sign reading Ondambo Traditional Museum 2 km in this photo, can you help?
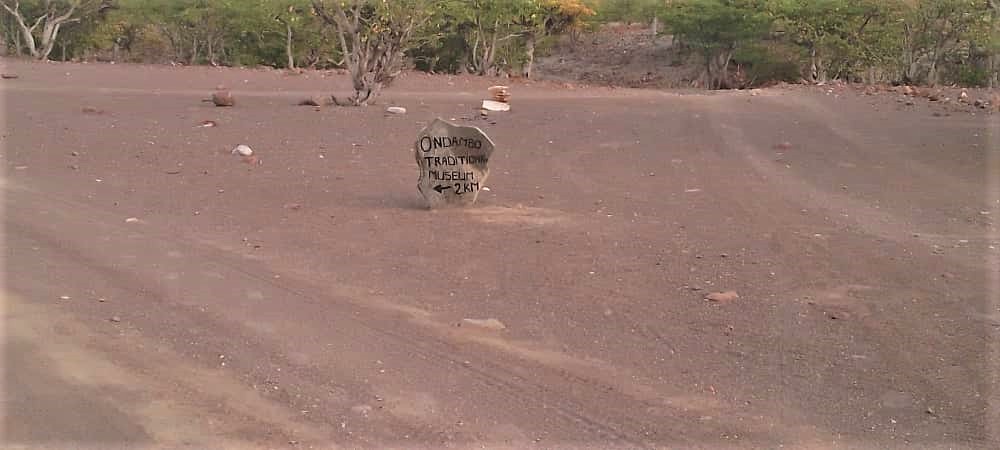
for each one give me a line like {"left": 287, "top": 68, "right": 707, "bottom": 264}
{"left": 413, "top": 119, "right": 493, "bottom": 208}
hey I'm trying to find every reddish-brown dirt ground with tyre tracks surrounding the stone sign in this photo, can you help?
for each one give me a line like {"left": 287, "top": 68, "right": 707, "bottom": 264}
{"left": 0, "top": 61, "right": 1000, "bottom": 449}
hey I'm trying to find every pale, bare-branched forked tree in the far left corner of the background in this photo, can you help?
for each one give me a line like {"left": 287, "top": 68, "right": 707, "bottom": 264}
{"left": 0, "top": 0, "right": 113, "bottom": 59}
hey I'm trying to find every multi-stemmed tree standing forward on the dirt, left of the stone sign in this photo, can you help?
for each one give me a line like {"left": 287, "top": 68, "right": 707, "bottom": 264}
{"left": 313, "top": 0, "right": 429, "bottom": 106}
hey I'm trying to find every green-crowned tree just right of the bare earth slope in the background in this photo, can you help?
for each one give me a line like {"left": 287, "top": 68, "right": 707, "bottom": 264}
{"left": 663, "top": 0, "right": 772, "bottom": 89}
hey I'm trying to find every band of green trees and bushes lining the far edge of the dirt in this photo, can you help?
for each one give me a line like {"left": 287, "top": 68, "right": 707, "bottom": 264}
{"left": 0, "top": 0, "right": 1000, "bottom": 88}
